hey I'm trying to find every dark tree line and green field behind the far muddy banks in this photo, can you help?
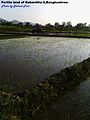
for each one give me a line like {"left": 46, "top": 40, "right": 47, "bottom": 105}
{"left": 0, "top": 21, "right": 90, "bottom": 33}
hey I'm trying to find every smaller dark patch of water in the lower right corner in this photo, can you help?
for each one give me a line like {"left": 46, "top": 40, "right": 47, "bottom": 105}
{"left": 49, "top": 78, "right": 90, "bottom": 120}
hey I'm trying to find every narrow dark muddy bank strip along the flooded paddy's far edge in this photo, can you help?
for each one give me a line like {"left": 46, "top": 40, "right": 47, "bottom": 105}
{"left": 0, "top": 31, "right": 90, "bottom": 38}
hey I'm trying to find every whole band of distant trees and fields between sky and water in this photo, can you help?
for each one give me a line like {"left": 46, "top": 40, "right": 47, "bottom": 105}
{"left": 0, "top": 20, "right": 90, "bottom": 39}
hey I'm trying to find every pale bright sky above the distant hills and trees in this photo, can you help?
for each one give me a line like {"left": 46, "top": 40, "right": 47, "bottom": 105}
{"left": 0, "top": 0, "right": 90, "bottom": 25}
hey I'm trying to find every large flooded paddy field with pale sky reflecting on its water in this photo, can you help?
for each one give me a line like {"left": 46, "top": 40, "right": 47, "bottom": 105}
{"left": 0, "top": 37, "right": 90, "bottom": 88}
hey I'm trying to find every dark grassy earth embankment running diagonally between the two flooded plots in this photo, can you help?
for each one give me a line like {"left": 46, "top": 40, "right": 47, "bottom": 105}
{"left": 0, "top": 58, "right": 90, "bottom": 120}
